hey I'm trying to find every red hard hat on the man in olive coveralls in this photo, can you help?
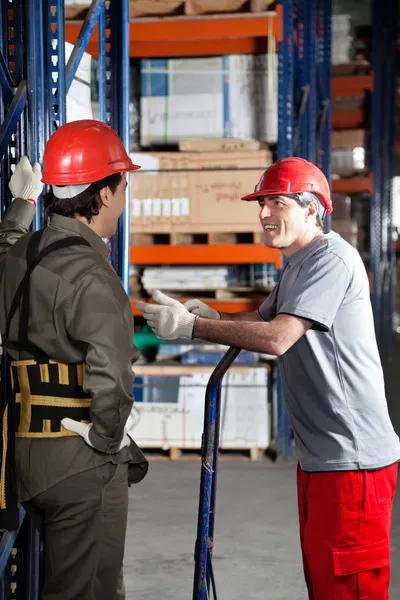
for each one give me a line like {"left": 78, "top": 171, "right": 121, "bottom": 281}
{"left": 42, "top": 119, "right": 140, "bottom": 185}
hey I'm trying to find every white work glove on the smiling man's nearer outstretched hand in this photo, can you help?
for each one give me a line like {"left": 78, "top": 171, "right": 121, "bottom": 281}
{"left": 136, "top": 290, "right": 198, "bottom": 340}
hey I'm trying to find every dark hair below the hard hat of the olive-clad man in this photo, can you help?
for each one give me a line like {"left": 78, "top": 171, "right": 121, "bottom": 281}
{"left": 42, "top": 173, "right": 122, "bottom": 223}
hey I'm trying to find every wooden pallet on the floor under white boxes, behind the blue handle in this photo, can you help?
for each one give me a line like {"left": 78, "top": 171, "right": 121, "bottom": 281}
{"left": 142, "top": 448, "right": 266, "bottom": 462}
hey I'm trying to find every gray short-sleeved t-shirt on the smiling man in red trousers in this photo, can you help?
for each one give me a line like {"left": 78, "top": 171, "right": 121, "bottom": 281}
{"left": 259, "top": 232, "right": 400, "bottom": 471}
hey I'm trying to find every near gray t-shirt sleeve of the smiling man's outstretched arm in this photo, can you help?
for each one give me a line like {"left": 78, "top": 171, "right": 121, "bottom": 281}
{"left": 278, "top": 251, "right": 351, "bottom": 331}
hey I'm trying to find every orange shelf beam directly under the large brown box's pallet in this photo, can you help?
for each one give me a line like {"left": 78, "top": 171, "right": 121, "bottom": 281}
{"left": 130, "top": 244, "right": 282, "bottom": 269}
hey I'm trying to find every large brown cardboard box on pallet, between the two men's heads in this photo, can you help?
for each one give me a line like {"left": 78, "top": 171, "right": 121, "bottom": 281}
{"left": 130, "top": 150, "right": 272, "bottom": 233}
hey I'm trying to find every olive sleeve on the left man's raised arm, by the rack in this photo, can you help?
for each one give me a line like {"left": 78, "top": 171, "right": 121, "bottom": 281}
{"left": 0, "top": 198, "right": 36, "bottom": 260}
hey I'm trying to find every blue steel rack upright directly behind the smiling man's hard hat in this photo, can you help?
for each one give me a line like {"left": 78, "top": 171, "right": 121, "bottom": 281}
{"left": 277, "top": 0, "right": 332, "bottom": 457}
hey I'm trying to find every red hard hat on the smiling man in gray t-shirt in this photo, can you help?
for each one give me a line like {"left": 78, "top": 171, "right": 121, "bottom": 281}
{"left": 242, "top": 157, "right": 333, "bottom": 215}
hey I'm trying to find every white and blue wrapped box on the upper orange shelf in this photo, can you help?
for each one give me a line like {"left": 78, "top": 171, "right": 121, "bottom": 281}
{"left": 140, "top": 52, "right": 278, "bottom": 148}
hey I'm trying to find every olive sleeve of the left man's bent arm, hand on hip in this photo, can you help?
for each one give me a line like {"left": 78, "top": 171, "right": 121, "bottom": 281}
{"left": 67, "top": 268, "right": 138, "bottom": 453}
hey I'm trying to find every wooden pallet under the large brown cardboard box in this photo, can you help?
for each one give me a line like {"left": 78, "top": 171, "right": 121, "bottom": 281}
{"left": 131, "top": 230, "right": 264, "bottom": 246}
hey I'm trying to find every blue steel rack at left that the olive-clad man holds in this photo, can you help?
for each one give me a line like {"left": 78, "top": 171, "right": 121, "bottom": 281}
{"left": 0, "top": 0, "right": 130, "bottom": 600}
